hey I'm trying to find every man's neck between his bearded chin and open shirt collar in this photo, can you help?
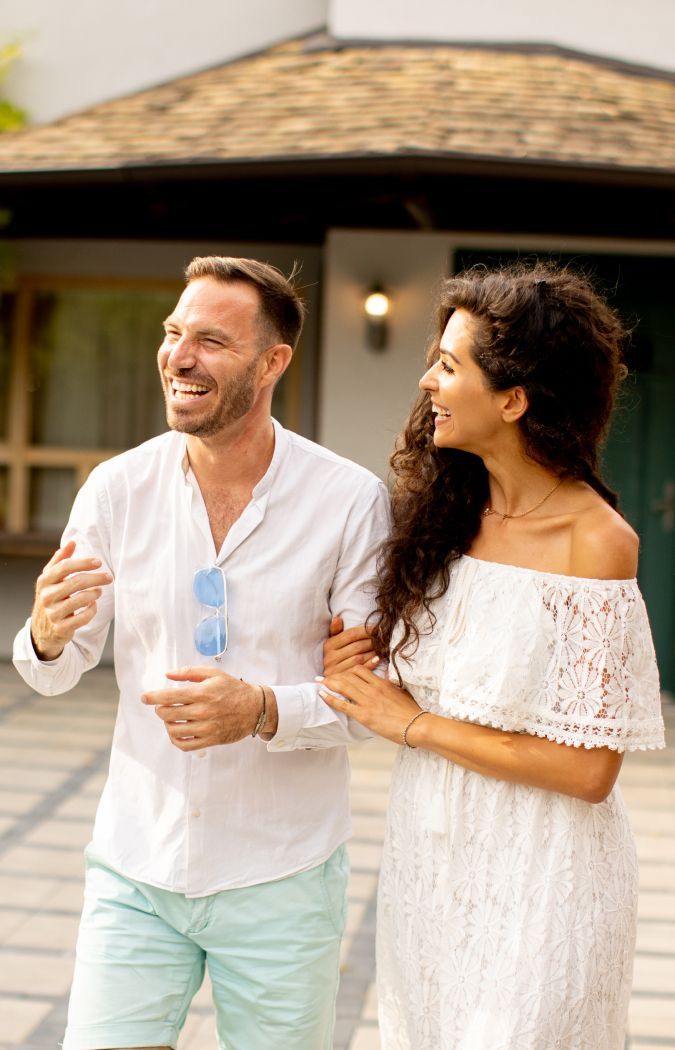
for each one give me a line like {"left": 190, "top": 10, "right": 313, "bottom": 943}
{"left": 187, "top": 414, "right": 274, "bottom": 490}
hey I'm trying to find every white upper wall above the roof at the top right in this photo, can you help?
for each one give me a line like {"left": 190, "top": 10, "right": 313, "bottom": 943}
{"left": 329, "top": 0, "right": 675, "bottom": 69}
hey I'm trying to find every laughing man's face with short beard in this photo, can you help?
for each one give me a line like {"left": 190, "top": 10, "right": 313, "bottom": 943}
{"left": 157, "top": 277, "right": 263, "bottom": 438}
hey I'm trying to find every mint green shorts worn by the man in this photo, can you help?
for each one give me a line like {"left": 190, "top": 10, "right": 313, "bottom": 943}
{"left": 63, "top": 846, "right": 349, "bottom": 1050}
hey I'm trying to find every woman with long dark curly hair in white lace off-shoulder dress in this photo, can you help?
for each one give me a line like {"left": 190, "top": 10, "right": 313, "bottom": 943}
{"left": 322, "top": 265, "right": 663, "bottom": 1050}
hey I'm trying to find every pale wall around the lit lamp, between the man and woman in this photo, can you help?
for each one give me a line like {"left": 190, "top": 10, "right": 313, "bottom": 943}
{"left": 318, "top": 230, "right": 448, "bottom": 477}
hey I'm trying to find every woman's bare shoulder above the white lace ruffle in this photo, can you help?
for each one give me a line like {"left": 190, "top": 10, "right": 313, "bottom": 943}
{"left": 570, "top": 492, "right": 639, "bottom": 580}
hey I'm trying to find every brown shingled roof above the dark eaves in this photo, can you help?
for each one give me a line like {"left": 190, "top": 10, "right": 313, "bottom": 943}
{"left": 0, "top": 38, "right": 675, "bottom": 173}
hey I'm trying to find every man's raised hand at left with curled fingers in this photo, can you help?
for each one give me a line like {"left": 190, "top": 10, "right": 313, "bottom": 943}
{"left": 30, "top": 541, "right": 112, "bottom": 660}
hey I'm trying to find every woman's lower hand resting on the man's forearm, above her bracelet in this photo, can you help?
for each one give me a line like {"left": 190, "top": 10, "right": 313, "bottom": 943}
{"left": 317, "top": 666, "right": 420, "bottom": 743}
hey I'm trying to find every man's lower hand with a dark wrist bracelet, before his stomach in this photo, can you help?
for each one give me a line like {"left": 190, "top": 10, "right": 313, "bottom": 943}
{"left": 141, "top": 667, "right": 278, "bottom": 751}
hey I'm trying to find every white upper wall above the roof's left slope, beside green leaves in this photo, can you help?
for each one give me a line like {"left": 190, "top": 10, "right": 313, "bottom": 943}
{"left": 0, "top": 0, "right": 326, "bottom": 123}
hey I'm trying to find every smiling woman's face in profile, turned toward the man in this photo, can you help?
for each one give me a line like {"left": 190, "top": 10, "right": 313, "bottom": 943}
{"left": 420, "top": 310, "right": 505, "bottom": 456}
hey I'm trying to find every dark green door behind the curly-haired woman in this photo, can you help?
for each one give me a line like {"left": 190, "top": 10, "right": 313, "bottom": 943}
{"left": 452, "top": 249, "right": 675, "bottom": 692}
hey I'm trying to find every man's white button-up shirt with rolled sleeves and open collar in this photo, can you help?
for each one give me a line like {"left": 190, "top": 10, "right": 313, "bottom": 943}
{"left": 14, "top": 423, "right": 388, "bottom": 897}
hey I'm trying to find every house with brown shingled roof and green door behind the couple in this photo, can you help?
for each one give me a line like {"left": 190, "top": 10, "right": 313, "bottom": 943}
{"left": 0, "top": 0, "right": 675, "bottom": 689}
